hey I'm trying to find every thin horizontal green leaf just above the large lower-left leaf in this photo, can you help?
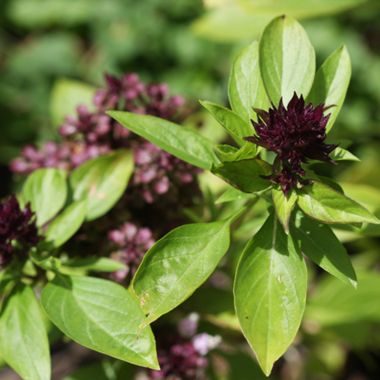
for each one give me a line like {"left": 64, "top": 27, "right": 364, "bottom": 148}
{"left": 61, "top": 257, "right": 126, "bottom": 273}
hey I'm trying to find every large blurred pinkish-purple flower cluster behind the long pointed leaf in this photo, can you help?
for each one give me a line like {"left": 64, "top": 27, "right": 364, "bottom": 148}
{"left": 11, "top": 74, "right": 199, "bottom": 203}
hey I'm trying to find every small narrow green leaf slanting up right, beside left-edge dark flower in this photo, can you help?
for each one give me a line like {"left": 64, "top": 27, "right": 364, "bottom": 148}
{"left": 45, "top": 201, "right": 87, "bottom": 247}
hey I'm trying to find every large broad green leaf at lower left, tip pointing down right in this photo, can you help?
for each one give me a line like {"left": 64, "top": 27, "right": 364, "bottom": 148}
{"left": 41, "top": 276, "right": 159, "bottom": 369}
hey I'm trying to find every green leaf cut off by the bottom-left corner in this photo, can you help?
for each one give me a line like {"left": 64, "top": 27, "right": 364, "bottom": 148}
{"left": 0, "top": 284, "right": 50, "bottom": 380}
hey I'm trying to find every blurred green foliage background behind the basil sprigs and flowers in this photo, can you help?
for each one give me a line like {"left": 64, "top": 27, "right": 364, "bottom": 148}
{"left": 0, "top": 0, "right": 380, "bottom": 380}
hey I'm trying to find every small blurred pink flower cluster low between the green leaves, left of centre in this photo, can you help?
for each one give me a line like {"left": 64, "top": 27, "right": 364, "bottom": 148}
{"left": 108, "top": 223, "right": 155, "bottom": 282}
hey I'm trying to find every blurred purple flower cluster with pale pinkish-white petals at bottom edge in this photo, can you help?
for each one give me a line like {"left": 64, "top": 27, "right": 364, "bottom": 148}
{"left": 150, "top": 313, "right": 221, "bottom": 380}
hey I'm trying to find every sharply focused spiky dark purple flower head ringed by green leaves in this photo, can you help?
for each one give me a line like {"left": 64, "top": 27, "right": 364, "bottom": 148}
{"left": 246, "top": 93, "right": 336, "bottom": 194}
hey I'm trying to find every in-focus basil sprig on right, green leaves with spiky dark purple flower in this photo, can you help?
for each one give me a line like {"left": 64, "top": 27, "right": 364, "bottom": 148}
{"left": 107, "top": 16, "right": 379, "bottom": 375}
